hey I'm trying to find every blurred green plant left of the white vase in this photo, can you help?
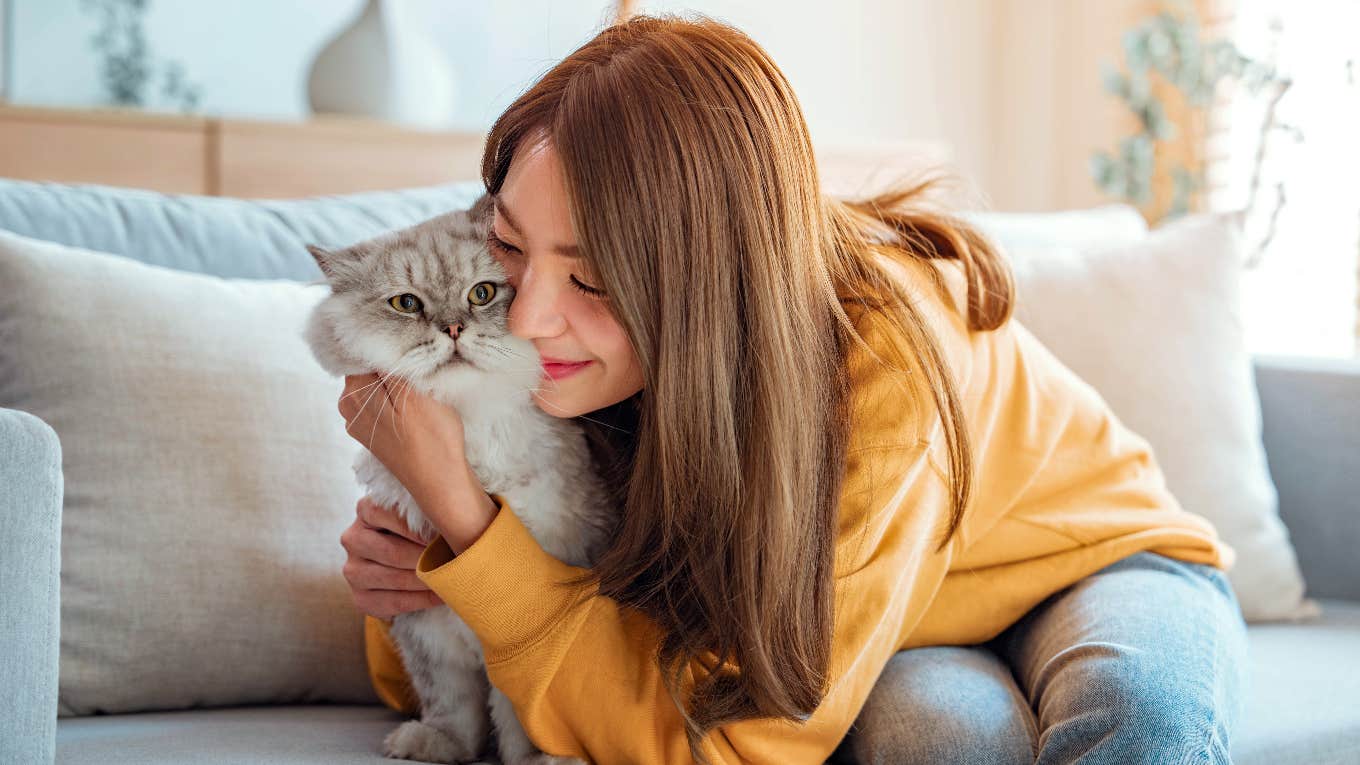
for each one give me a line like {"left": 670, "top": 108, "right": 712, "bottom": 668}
{"left": 80, "top": 0, "right": 201, "bottom": 112}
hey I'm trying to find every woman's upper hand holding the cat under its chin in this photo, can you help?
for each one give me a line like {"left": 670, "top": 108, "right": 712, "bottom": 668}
{"left": 339, "top": 373, "right": 465, "bottom": 503}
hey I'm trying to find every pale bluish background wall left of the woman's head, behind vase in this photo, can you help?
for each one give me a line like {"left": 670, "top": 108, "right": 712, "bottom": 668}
{"left": 12, "top": 0, "right": 617, "bottom": 128}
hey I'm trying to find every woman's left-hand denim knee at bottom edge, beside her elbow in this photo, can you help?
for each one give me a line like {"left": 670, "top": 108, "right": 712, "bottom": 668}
{"left": 845, "top": 645, "right": 1038, "bottom": 765}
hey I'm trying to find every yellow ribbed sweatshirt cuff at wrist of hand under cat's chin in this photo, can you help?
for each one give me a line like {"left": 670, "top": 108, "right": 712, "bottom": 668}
{"left": 416, "top": 494, "right": 590, "bottom": 664}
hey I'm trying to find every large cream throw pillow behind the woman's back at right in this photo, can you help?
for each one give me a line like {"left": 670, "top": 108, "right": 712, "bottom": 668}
{"left": 1000, "top": 214, "right": 1321, "bottom": 622}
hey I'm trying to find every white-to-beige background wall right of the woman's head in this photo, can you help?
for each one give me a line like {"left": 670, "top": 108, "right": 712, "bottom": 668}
{"left": 643, "top": 0, "right": 1153, "bottom": 210}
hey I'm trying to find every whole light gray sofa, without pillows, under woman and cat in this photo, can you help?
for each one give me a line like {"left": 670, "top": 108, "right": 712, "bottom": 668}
{"left": 0, "top": 180, "right": 1360, "bottom": 765}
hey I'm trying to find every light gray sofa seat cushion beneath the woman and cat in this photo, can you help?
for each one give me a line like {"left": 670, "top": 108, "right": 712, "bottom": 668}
{"left": 57, "top": 600, "right": 1360, "bottom": 765}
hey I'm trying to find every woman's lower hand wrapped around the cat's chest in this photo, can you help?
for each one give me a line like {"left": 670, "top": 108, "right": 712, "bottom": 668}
{"left": 340, "top": 497, "right": 443, "bottom": 619}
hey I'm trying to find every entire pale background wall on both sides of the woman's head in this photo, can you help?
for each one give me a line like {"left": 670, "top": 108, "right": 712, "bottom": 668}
{"left": 10, "top": 0, "right": 1148, "bottom": 210}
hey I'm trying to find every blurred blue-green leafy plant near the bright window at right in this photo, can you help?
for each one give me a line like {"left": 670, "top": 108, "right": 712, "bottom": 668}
{"left": 1091, "top": 0, "right": 1289, "bottom": 218}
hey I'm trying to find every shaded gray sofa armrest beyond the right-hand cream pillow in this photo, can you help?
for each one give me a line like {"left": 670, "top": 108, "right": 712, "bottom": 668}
{"left": 1254, "top": 355, "right": 1360, "bottom": 600}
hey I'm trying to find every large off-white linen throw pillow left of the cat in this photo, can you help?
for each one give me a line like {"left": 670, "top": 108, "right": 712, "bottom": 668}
{"left": 0, "top": 231, "right": 378, "bottom": 716}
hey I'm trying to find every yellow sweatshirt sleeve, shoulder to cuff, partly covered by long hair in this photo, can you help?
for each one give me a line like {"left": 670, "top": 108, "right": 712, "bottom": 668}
{"left": 416, "top": 306, "right": 952, "bottom": 765}
